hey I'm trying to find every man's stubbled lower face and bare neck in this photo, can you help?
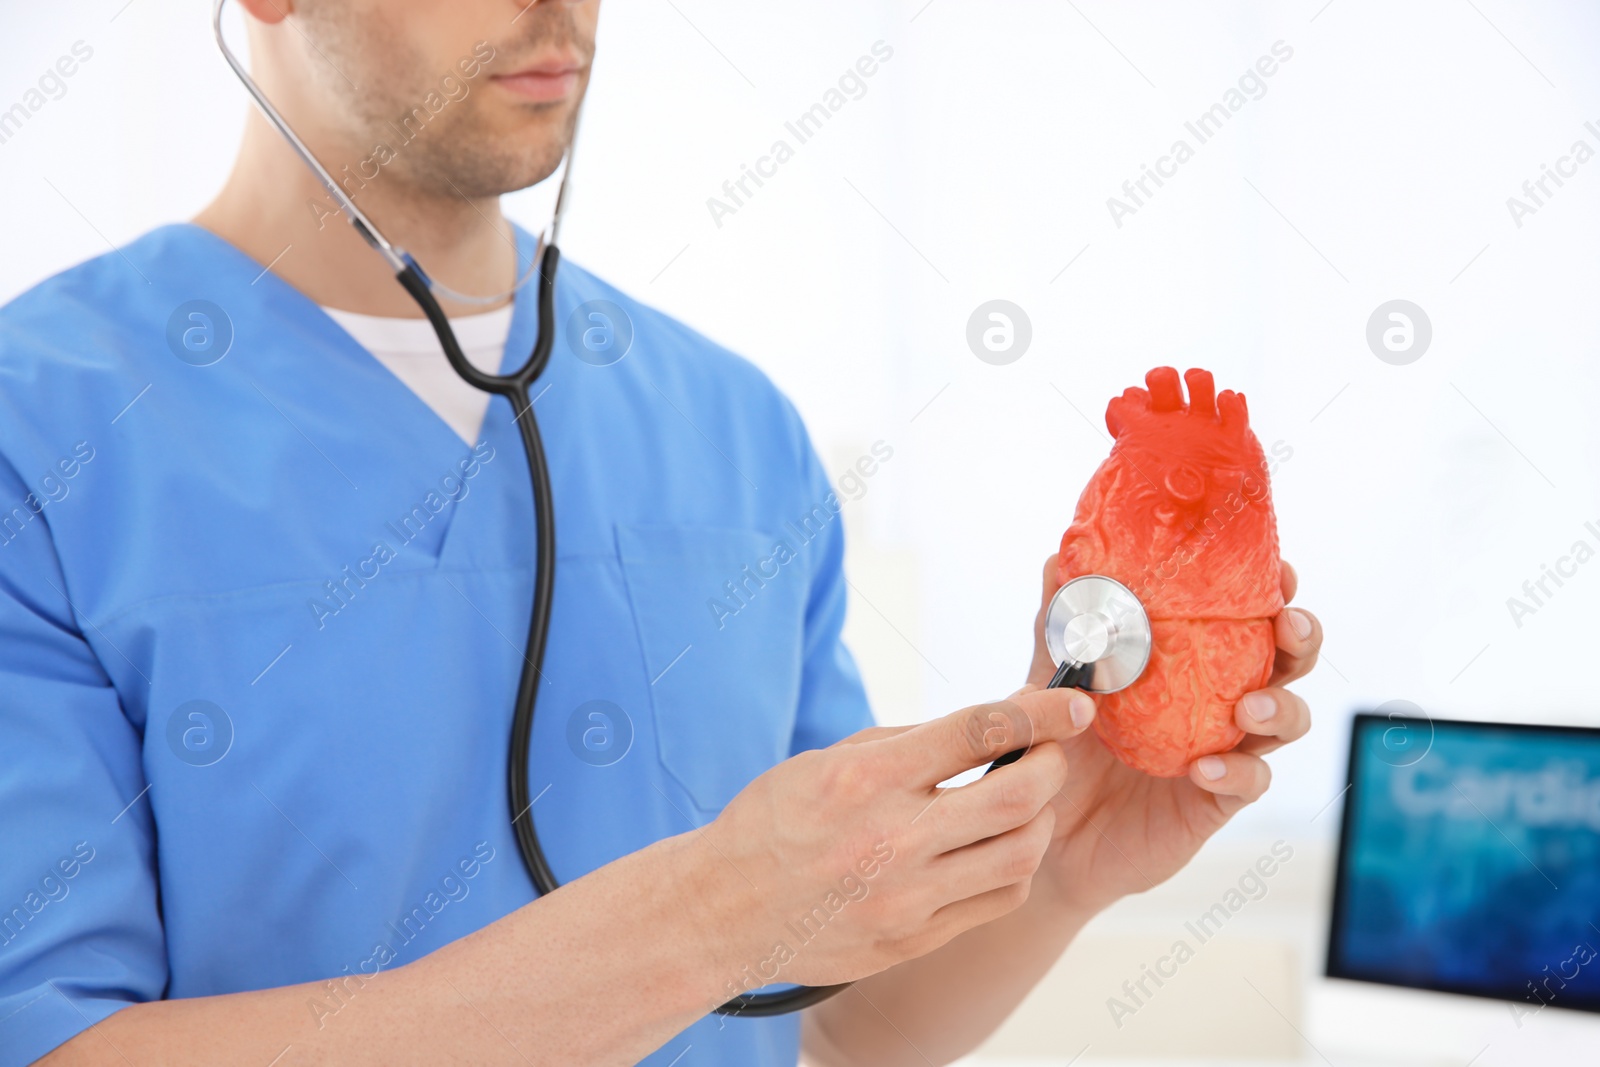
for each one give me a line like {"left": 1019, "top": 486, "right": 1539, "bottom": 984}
{"left": 194, "top": 0, "right": 598, "bottom": 318}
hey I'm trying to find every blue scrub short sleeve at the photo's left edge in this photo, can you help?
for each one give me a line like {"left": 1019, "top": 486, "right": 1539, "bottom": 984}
{"left": 0, "top": 461, "right": 166, "bottom": 1067}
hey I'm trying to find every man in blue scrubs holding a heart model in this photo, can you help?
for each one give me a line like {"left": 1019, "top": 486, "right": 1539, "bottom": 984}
{"left": 0, "top": 0, "right": 1322, "bottom": 1067}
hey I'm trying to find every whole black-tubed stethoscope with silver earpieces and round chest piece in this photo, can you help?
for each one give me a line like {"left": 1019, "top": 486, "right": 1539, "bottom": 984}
{"left": 211, "top": 0, "right": 1150, "bottom": 1017}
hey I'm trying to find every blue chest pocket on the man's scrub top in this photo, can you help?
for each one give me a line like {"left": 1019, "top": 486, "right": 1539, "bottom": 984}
{"left": 616, "top": 525, "right": 810, "bottom": 814}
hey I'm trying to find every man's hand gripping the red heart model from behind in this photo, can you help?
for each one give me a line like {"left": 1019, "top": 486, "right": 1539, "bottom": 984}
{"left": 1017, "top": 557, "right": 1322, "bottom": 913}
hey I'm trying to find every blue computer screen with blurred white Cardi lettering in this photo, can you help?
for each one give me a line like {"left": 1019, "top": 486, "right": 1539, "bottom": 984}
{"left": 1328, "top": 715, "right": 1600, "bottom": 1011}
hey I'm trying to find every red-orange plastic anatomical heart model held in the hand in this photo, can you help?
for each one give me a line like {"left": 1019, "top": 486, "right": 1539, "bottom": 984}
{"left": 1058, "top": 366, "right": 1283, "bottom": 777}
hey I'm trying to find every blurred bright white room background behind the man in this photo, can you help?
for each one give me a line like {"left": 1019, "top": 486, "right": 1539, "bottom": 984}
{"left": 0, "top": 0, "right": 1600, "bottom": 1067}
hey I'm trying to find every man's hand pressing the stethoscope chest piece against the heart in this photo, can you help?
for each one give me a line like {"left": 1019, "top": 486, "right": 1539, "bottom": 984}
{"left": 702, "top": 689, "right": 1093, "bottom": 992}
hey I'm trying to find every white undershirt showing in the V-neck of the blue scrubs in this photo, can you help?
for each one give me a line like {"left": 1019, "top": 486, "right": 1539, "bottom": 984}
{"left": 322, "top": 304, "right": 512, "bottom": 445}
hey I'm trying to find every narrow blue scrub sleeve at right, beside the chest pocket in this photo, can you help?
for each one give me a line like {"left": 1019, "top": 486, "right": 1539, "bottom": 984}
{"left": 789, "top": 416, "right": 874, "bottom": 755}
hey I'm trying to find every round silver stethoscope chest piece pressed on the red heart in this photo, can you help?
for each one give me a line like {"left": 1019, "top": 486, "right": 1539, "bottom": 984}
{"left": 1045, "top": 574, "right": 1150, "bottom": 693}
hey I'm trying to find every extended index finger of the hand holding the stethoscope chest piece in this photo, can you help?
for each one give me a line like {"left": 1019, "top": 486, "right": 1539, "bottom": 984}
{"left": 883, "top": 689, "right": 1094, "bottom": 785}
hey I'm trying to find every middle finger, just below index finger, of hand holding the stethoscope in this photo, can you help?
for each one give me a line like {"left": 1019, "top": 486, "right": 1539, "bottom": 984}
{"left": 912, "top": 741, "right": 1069, "bottom": 854}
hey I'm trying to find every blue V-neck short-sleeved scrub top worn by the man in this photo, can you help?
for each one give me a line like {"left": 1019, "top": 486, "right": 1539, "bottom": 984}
{"left": 0, "top": 226, "right": 870, "bottom": 1067}
